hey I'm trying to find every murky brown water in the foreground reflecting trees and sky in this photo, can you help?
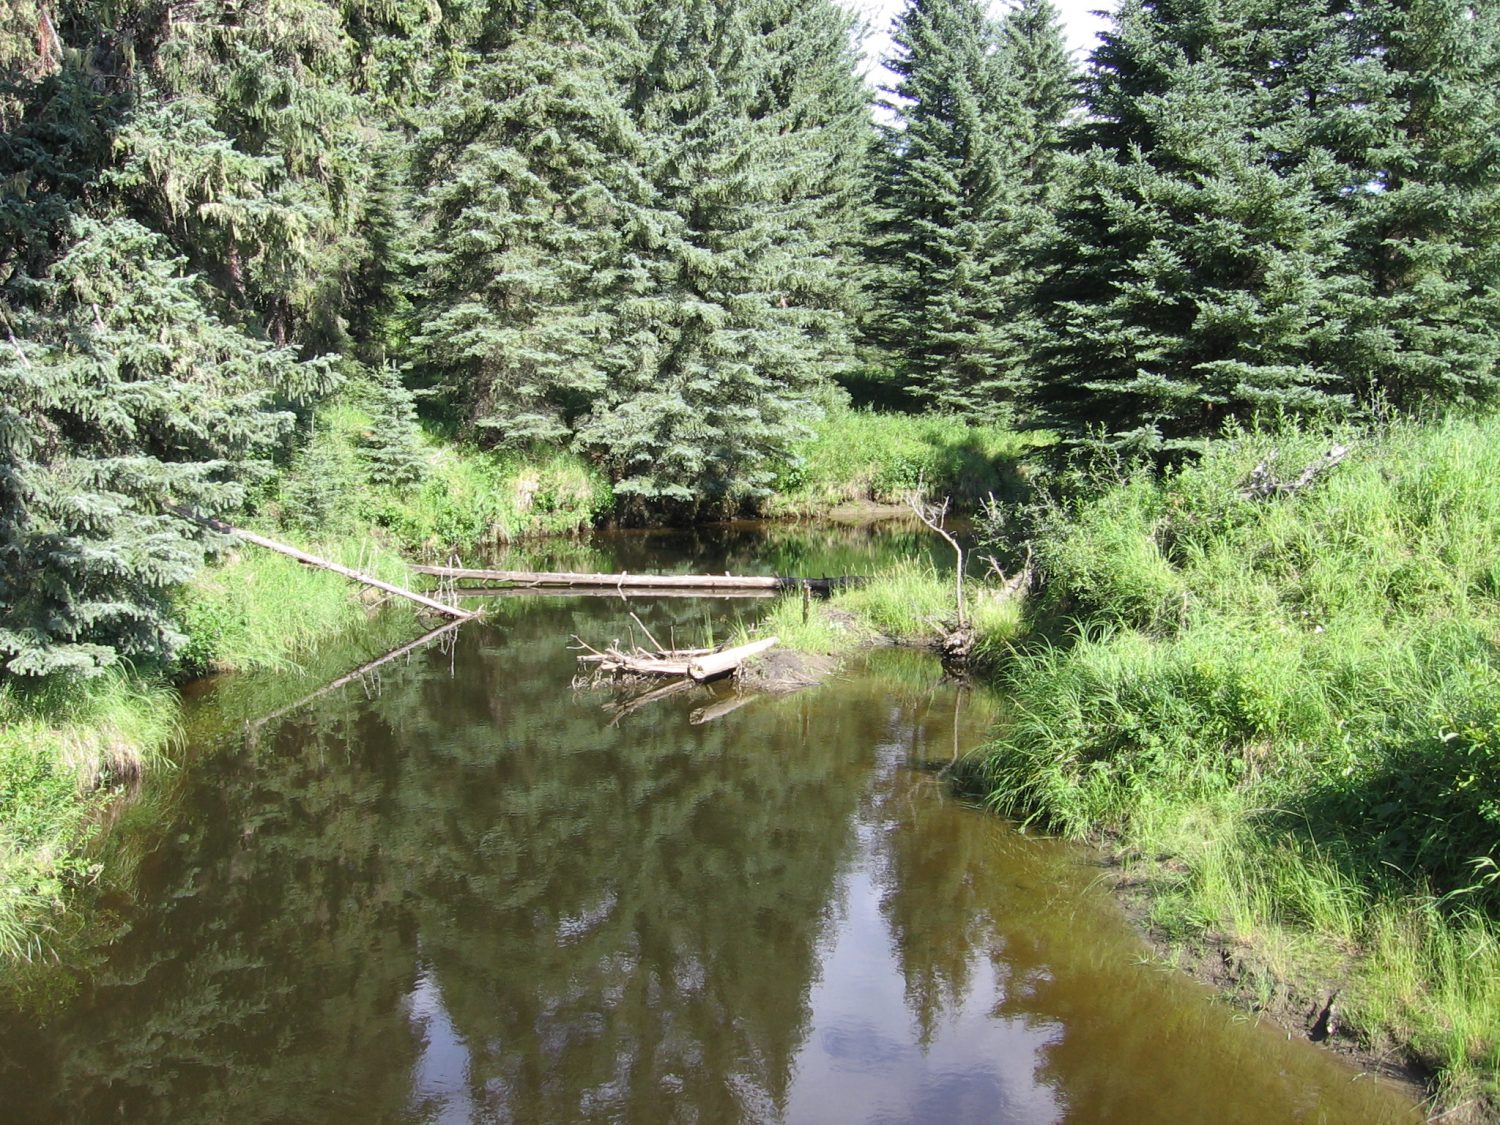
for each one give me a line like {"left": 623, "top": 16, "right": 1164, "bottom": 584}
{"left": 0, "top": 531, "right": 1419, "bottom": 1125}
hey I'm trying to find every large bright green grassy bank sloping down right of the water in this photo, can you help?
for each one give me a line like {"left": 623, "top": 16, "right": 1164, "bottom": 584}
{"left": 980, "top": 419, "right": 1500, "bottom": 1107}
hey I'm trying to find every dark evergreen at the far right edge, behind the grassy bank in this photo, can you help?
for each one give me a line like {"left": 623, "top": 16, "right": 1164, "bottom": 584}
{"left": 1335, "top": 0, "right": 1500, "bottom": 410}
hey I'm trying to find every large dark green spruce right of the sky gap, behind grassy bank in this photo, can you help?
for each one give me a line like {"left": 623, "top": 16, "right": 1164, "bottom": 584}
{"left": 1037, "top": 0, "right": 1349, "bottom": 450}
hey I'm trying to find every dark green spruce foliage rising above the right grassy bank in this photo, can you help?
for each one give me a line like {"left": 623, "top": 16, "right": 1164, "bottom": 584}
{"left": 1035, "top": 0, "right": 1500, "bottom": 453}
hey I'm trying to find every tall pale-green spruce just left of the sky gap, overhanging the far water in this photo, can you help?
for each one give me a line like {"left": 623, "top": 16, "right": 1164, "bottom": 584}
{"left": 578, "top": 0, "right": 863, "bottom": 504}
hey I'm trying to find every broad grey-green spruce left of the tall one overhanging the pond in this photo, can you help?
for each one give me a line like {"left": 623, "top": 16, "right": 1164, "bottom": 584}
{"left": 413, "top": 2, "right": 647, "bottom": 444}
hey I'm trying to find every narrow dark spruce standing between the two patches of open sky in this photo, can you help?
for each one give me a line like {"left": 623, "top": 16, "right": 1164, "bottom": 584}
{"left": 872, "top": 0, "right": 1058, "bottom": 416}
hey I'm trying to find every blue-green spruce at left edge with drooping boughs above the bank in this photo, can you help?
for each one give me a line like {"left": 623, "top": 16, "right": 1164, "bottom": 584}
{"left": 0, "top": 48, "right": 327, "bottom": 675}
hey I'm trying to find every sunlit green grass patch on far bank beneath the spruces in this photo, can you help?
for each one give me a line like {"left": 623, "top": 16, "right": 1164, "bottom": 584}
{"left": 767, "top": 407, "right": 1047, "bottom": 516}
